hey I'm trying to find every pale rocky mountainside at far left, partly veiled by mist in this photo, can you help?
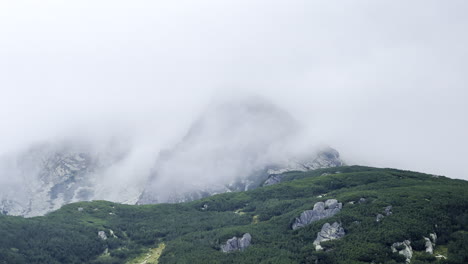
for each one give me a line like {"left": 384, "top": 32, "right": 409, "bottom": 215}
{"left": 0, "top": 143, "right": 139, "bottom": 217}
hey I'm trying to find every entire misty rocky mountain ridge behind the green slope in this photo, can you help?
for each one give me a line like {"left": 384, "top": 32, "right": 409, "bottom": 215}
{"left": 0, "top": 97, "right": 344, "bottom": 217}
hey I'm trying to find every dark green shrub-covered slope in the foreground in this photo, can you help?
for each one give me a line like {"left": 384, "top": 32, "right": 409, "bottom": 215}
{"left": 0, "top": 166, "right": 468, "bottom": 263}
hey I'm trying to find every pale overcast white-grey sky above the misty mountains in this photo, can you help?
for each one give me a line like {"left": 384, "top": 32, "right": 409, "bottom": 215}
{"left": 0, "top": 0, "right": 468, "bottom": 179}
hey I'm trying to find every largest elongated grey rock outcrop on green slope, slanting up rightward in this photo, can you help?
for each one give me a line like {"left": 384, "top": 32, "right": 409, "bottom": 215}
{"left": 292, "top": 199, "right": 343, "bottom": 230}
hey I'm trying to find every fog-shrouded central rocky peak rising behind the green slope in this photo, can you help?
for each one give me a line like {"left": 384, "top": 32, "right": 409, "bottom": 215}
{"left": 138, "top": 97, "right": 343, "bottom": 204}
